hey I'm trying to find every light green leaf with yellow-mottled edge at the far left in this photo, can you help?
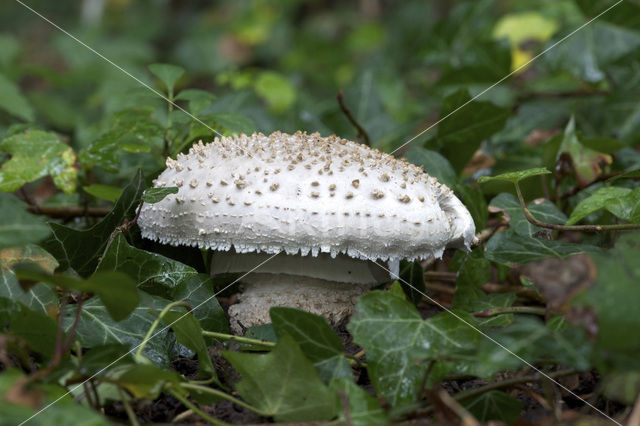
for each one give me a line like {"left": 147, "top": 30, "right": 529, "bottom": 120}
{"left": 0, "top": 130, "right": 78, "bottom": 193}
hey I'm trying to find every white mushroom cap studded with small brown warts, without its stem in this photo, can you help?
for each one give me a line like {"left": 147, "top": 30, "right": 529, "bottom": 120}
{"left": 138, "top": 132, "right": 475, "bottom": 264}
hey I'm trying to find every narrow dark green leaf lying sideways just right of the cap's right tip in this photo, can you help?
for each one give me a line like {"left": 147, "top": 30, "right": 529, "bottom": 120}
{"left": 485, "top": 230, "right": 598, "bottom": 265}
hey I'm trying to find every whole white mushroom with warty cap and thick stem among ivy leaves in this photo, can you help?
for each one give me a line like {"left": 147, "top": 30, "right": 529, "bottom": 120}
{"left": 138, "top": 132, "right": 475, "bottom": 333}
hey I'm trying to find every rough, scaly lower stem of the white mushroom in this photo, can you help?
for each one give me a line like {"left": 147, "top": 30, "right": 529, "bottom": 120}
{"left": 229, "top": 273, "right": 370, "bottom": 335}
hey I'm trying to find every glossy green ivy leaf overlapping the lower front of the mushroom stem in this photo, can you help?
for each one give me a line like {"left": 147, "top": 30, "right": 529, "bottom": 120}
{"left": 269, "top": 307, "right": 352, "bottom": 383}
